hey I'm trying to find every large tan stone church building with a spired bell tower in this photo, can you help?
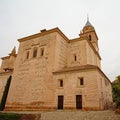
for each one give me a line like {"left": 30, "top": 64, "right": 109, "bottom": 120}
{"left": 0, "top": 19, "right": 112, "bottom": 111}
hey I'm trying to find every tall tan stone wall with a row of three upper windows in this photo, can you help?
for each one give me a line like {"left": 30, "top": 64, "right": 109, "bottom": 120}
{"left": 6, "top": 34, "right": 55, "bottom": 110}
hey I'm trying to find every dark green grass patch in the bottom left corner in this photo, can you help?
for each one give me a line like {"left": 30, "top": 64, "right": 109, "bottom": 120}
{"left": 0, "top": 113, "right": 20, "bottom": 120}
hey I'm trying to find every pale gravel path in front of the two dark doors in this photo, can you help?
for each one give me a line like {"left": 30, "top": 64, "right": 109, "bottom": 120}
{"left": 41, "top": 110, "right": 120, "bottom": 120}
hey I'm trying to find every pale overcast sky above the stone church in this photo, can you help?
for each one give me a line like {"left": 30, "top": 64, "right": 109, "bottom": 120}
{"left": 0, "top": 0, "right": 120, "bottom": 81}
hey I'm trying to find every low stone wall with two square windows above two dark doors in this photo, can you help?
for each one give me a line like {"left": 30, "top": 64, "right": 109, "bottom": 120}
{"left": 54, "top": 70, "right": 112, "bottom": 110}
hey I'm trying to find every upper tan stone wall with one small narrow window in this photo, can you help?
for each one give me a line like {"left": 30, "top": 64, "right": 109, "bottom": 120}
{"left": 67, "top": 40, "right": 87, "bottom": 67}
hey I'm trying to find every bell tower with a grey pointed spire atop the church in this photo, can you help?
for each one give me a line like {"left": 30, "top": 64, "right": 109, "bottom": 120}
{"left": 80, "top": 17, "right": 99, "bottom": 52}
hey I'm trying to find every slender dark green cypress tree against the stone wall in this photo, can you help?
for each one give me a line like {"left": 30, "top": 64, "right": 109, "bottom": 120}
{"left": 0, "top": 76, "right": 12, "bottom": 111}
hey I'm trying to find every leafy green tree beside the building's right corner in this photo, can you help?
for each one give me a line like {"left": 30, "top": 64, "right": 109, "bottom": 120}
{"left": 112, "top": 76, "right": 120, "bottom": 107}
